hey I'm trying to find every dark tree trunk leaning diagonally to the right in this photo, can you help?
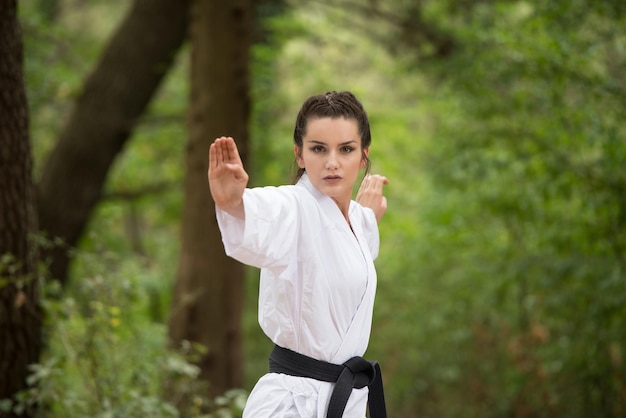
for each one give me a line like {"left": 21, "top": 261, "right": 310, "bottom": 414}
{"left": 37, "top": 0, "right": 190, "bottom": 282}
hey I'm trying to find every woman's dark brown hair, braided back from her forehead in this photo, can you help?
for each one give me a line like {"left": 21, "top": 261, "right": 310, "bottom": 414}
{"left": 293, "top": 91, "right": 372, "bottom": 181}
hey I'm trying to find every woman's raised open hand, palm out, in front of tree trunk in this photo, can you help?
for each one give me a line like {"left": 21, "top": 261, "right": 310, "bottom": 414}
{"left": 208, "top": 136, "right": 249, "bottom": 219}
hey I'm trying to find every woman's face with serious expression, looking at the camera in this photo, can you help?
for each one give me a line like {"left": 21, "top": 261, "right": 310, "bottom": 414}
{"left": 294, "top": 118, "right": 369, "bottom": 209}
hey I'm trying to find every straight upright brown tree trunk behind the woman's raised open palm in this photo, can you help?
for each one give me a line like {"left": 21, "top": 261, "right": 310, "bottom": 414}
{"left": 169, "top": 0, "right": 252, "bottom": 396}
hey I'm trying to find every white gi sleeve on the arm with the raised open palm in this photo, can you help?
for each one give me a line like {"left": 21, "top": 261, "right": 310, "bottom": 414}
{"left": 215, "top": 187, "right": 299, "bottom": 268}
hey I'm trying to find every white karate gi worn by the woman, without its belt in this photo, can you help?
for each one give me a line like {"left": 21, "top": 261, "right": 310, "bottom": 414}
{"left": 217, "top": 174, "right": 379, "bottom": 418}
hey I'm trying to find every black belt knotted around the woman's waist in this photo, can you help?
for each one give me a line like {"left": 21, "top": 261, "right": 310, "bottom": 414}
{"left": 270, "top": 345, "right": 387, "bottom": 418}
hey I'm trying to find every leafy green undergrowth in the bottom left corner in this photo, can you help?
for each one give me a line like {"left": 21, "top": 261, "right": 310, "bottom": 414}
{"left": 0, "top": 247, "right": 246, "bottom": 418}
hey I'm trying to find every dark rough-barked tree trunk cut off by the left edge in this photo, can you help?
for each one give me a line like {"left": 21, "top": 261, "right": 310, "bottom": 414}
{"left": 0, "top": 0, "right": 41, "bottom": 417}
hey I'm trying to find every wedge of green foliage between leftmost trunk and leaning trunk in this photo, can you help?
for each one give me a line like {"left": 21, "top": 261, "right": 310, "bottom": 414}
{"left": 19, "top": 0, "right": 130, "bottom": 173}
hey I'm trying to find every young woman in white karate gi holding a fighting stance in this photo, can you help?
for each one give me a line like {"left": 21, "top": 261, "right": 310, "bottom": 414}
{"left": 208, "top": 92, "right": 388, "bottom": 418}
